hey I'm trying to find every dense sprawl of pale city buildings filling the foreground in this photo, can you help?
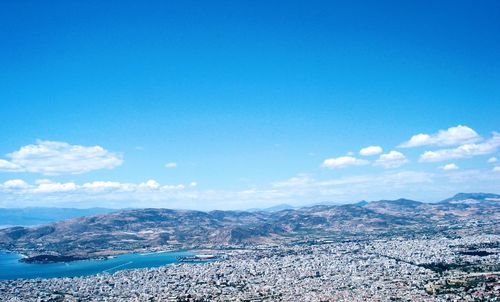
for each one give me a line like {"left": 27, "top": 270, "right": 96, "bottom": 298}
{"left": 0, "top": 235, "right": 500, "bottom": 301}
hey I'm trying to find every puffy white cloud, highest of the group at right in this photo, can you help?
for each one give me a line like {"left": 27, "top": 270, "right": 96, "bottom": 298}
{"left": 399, "top": 125, "right": 481, "bottom": 148}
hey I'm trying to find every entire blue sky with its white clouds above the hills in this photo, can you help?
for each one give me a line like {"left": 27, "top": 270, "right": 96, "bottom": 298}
{"left": 0, "top": 1, "right": 500, "bottom": 209}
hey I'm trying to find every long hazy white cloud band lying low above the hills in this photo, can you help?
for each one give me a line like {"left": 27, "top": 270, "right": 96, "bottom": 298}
{"left": 0, "top": 167, "right": 500, "bottom": 210}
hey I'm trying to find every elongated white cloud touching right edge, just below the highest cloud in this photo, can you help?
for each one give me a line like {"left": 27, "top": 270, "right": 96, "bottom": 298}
{"left": 420, "top": 133, "right": 500, "bottom": 162}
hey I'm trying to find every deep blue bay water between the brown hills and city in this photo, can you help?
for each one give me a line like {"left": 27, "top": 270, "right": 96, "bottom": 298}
{"left": 0, "top": 251, "right": 194, "bottom": 280}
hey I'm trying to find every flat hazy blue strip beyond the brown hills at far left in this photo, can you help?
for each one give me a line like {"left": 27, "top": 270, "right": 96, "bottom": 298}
{"left": 0, "top": 207, "right": 118, "bottom": 226}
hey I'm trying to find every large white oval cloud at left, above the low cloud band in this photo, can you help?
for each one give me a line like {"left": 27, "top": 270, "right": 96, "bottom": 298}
{"left": 0, "top": 140, "right": 123, "bottom": 175}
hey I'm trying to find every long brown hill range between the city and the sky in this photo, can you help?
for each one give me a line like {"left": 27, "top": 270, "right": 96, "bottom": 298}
{"left": 0, "top": 193, "right": 500, "bottom": 258}
